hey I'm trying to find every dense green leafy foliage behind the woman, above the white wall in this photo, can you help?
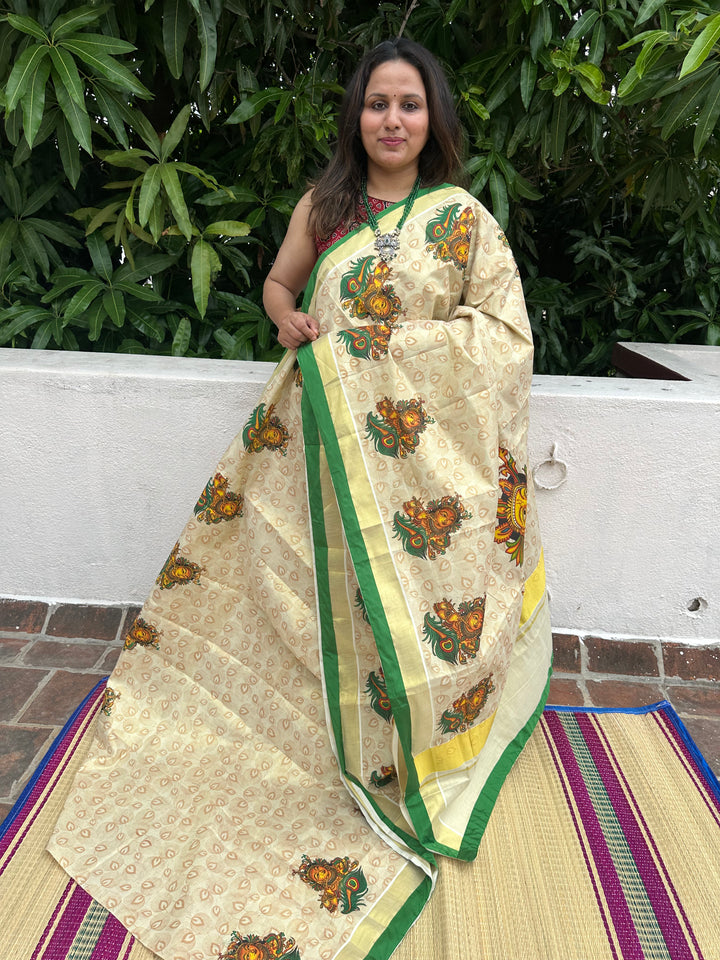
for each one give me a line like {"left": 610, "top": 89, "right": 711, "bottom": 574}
{"left": 0, "top": 0, "right": 720, "bottom": 374}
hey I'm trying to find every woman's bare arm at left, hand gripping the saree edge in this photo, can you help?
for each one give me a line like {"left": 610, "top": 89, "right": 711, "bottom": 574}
{"left": 263, "top": 193, "right": 318, "bottom": 349}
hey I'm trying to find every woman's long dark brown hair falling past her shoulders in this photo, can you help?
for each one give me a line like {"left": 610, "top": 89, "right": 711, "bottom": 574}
{"left": 309, "top": 37, "right": 462, "bottom": 238}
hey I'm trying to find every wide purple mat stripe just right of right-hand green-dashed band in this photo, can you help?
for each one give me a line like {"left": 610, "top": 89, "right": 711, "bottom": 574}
{"left": 576, "top": 714, "right": 702, "bottom": 960}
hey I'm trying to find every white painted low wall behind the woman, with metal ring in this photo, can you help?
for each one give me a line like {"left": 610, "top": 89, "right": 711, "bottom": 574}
{"left": 0, "top": 349, "right": 720, "bottom": 642}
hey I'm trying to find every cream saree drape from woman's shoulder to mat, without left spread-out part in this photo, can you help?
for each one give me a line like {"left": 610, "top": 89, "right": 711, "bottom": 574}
{"left": 298, "top": 187, "right": 551, "bottom": 859}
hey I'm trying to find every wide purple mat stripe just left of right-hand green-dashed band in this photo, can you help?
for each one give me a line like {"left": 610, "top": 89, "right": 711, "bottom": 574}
{"left": 546, "top": 713, "right": 645, "bottom": 960}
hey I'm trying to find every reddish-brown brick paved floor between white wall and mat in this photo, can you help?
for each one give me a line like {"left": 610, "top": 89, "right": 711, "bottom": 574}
{"left": 0, "top": 600, "right": 720, "bottom": 821}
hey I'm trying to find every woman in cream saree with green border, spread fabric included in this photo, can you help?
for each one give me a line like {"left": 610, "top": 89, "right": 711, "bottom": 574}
{"left": 50, "top": 40, "right": 550, "bottom": 960}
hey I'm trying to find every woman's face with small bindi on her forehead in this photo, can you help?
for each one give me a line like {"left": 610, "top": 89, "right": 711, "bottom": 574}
{"left": 360, "top": 60, "right": 430, "bottom": 180}
